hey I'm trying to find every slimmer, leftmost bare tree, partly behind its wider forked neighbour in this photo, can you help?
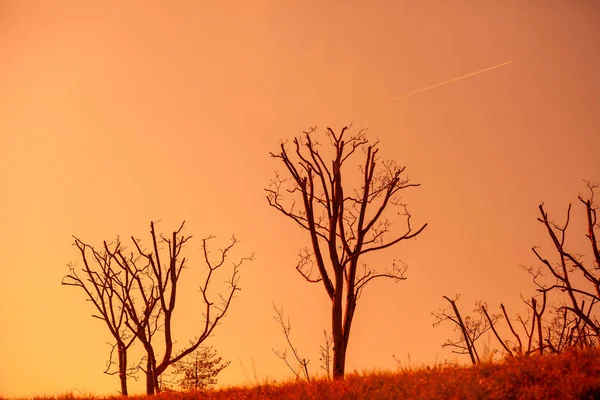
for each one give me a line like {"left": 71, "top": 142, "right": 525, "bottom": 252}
{"left": 62, "top": 237, "right": 136, "bottom": 396}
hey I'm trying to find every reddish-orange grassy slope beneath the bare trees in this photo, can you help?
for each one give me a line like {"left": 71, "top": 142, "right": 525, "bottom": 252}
{"left": 4, "top": 349, "right": 600, "bottom": 400}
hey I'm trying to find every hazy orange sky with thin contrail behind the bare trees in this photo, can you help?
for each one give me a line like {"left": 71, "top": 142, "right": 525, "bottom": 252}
{"left": 0, "top": 1, "right": 600, "bottom": 396}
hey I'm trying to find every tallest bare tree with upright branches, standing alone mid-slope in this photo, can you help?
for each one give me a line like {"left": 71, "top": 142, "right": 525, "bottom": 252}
{"left": 266, "top": 127, "right": 427, "bottom": 379}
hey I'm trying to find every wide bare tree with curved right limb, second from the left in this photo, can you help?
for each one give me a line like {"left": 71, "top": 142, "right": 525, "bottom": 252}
{"left": 67, "top": 222, "right": 253, "bottom": 394}
